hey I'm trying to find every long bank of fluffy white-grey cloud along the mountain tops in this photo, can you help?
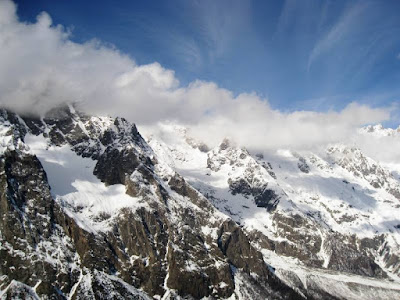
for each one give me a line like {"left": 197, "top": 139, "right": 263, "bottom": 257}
{"left": 0, "top": 1, "right": 390, "bottom": 149}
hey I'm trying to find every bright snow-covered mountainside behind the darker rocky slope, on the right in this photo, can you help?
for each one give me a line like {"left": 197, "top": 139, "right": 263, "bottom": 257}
{"left": 142, "top": 124, "right": 400, "bottom": 299}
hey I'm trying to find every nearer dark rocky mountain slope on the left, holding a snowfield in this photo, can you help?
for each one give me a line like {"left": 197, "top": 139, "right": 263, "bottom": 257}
{"left": 0, "top": 107, "right": 306, "bottom": 299}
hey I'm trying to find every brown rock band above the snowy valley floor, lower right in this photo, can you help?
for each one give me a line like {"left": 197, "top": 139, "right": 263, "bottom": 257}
{"left": 251, "top": 213, "right": 395, "bottom": 278}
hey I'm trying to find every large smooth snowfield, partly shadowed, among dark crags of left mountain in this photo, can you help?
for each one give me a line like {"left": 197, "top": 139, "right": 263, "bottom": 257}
{"left": 25, "top": 134, "right": 147, "bottom": 232}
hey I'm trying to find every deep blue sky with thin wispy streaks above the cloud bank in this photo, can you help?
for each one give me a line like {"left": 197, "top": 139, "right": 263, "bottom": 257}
{"left": 15, "top": 0, "right": 400, "bottom": 126}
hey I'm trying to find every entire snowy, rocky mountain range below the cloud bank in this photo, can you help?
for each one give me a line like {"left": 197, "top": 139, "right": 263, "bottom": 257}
{"left": 0, "top": 107, "right": 400, "bottom": 299}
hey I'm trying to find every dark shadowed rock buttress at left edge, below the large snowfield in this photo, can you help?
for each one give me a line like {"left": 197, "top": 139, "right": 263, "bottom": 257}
{"left": 0, "top": 151, "right": 79, "bottom": 299}
